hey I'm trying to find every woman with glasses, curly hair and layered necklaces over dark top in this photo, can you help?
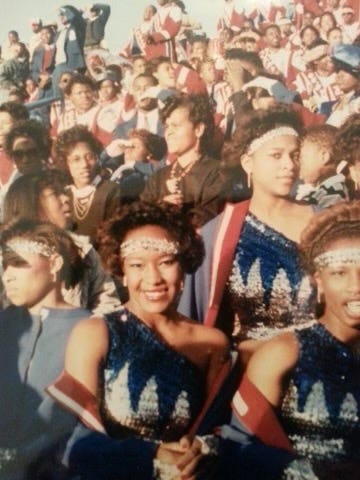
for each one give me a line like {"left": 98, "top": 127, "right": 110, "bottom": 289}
{"left": 54, "top": 125, "right": 120, "bottom": 242}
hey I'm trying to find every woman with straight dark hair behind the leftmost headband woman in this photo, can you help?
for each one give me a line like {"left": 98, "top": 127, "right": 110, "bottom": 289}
{"left": 0, "top": 169, "right": 121, "bottom": 315}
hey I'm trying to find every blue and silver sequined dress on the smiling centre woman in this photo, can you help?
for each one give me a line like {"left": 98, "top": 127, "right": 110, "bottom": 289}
{"left": 99, "top": 309, "right": 205, "bottom": 441}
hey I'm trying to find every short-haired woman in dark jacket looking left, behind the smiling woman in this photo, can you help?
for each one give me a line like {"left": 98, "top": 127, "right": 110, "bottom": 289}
{"left": 141, "top": 94, "right": 226, "bottom": 226}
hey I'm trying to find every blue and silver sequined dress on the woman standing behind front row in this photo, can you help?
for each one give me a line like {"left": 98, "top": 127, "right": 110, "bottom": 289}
{"left": 226, "top": 213, "right": 315, "bottom": 340}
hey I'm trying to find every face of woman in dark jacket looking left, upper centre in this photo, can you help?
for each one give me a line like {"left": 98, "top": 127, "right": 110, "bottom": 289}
{"left": 165, "top": 107, "right": 203, "bottom": 156}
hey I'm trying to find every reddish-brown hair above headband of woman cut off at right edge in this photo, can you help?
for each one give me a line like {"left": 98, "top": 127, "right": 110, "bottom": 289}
{"left": 300, "top": 201, "right": 360, "bottom": 274}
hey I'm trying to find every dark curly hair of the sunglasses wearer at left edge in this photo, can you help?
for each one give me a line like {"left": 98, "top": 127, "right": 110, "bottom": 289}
{"left": 5, "top": 119, "right": 51, "bottom": 163}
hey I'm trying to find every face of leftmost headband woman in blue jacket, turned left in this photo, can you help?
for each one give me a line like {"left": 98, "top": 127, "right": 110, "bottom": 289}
{"left": 2, "top": 253, "right": 54, "bottom": 311}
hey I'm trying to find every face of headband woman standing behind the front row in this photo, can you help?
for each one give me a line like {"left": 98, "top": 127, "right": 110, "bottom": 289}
{"left": 242, "top": 135, "right": 299, "bottom": 197}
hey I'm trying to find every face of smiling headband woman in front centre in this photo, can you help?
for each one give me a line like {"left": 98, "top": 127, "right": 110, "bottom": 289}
{"left": 123, "top": 225, "right": 183, "bottom": 320}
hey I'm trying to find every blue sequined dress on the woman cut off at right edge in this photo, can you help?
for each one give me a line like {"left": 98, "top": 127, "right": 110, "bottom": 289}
{"left": 280, "top": 324, "right": 360, "bottom": 464}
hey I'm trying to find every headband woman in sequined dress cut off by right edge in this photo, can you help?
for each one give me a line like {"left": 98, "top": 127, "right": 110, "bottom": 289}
{"left": 217, "top": 202, "right": 360, "bottom": 480}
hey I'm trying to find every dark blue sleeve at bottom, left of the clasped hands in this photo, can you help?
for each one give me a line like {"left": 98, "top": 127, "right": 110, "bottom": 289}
{"left": 63, "top": 425, "right": 157, "bottom": 480}
